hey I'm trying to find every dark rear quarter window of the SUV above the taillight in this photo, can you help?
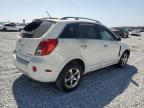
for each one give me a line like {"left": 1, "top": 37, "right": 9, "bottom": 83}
{"left": 60, "top": 24, "right": 78, "bottom": 38}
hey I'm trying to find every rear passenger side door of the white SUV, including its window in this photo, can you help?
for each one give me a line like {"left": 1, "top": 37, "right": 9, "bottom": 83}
{"left": 79, "top": 23, "right": 102, "bottom": 71}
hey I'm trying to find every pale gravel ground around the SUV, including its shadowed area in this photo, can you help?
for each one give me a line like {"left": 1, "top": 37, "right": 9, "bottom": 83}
{"left": 0, "top": 32, "right": 144, "bottom": 108}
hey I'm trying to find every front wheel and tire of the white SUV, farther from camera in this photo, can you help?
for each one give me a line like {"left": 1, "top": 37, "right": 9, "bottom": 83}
{"left": 117, "top": 52, "right": 129, "bottom": 68}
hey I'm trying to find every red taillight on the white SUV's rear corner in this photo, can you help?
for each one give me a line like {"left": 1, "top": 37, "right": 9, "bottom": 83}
{"left": 35, "top": 39, "right": 58, "bottom": 56}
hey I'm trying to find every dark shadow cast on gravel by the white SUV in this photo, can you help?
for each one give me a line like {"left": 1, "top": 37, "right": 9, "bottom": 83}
{"left": 13, "top": 65, "right": 138, "bottom": 108}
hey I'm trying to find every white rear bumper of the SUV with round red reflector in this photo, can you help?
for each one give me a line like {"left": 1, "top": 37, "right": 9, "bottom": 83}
{"left": 13, "top": 54, "right": 59, "bottom": 82}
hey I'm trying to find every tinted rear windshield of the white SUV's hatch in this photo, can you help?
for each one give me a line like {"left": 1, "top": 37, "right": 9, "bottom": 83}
{"left": 20, "top": 21, "right": 54, "bottom": 38}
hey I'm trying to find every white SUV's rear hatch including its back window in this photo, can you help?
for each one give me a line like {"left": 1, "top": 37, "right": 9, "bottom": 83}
{"left": 16, "top": 20, "right": 54, "bottom": 60}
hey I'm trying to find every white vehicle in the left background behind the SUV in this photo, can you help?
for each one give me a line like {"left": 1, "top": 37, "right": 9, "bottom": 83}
{"left": 1, "top": 23, "right": 22, "bottom": 31}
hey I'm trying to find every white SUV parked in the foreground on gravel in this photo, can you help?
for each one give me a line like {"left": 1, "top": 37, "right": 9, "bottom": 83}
{"left": 14, "top": 17, "right": 130, "bottom": 91}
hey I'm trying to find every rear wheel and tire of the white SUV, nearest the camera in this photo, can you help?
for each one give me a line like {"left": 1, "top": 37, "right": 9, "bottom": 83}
{"left": 56, "top": 62, "right": 83, "bottom": 92}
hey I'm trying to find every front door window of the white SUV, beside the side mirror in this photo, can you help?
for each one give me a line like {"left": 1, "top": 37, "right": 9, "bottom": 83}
{"left": 100, "top": 28, "right": 115, "bottom": 41}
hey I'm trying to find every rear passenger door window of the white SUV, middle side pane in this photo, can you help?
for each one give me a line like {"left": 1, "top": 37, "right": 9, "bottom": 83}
{"left": 79, "top": 24, "right": 100, "bottom": 39}
